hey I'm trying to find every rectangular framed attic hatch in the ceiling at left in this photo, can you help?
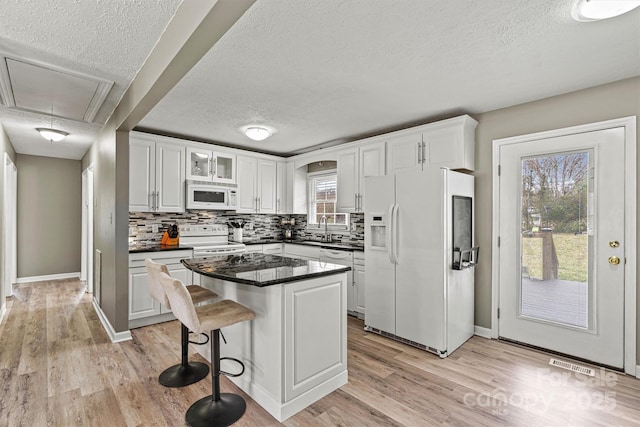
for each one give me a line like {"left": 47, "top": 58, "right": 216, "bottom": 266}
{"left": 0, "top": 56, "right": 113, "bottom": 123}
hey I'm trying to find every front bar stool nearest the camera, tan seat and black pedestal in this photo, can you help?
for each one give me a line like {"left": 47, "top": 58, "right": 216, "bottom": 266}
{"left": 160, "top": 273, "right": 256, "bottom": 427}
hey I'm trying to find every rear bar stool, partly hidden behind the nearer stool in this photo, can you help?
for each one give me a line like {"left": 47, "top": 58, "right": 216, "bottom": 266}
{"left": 145, "top": 258, "right": 218, "bottom": 387}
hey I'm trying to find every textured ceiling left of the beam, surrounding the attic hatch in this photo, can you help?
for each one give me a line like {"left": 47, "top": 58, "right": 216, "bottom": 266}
{"left": 0, "top": 0, "right": 180, "bottom": 159}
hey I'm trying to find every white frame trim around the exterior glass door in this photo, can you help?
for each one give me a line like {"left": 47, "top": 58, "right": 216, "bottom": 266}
{"left": 491, "top": 116, "right": 640, "bottom": 376}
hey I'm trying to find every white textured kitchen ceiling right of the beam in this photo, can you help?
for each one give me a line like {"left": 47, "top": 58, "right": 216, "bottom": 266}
{"left": 140, "top": 0, "right": 640, "bottom": 153}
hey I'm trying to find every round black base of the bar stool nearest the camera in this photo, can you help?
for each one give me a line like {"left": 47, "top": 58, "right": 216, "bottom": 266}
{"left": 185, "top": 393, "right": 247, "bottom": 427}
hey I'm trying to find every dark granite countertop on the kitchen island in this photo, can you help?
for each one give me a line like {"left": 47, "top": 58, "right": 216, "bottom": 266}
{"left": 182, "top": 253, "right": 351, "bottom": 287}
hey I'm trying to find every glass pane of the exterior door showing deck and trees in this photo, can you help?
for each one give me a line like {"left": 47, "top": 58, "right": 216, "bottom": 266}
{"left": 519, "top": 151, "right": 593, "bottom": 328}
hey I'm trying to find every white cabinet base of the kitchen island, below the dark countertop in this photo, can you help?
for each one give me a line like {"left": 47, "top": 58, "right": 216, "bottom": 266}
{"left": 197, "top": 273, "right": 348, "bottom": 421}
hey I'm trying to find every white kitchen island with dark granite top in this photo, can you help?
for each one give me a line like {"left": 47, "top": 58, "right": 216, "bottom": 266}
{"left": 182, "top": 253, "right": 350, "bottom": 421}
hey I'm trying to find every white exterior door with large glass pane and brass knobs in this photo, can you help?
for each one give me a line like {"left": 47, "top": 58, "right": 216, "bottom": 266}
{"left": 498, "top": 127, "right": 625, "bottom": 368}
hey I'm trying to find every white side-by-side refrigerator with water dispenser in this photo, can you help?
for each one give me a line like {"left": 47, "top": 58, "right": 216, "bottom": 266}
{"left": 365, "top": 168, "right": 477, "bottom": 357}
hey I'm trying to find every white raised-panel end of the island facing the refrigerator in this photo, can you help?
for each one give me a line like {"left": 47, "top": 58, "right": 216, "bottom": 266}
{"left": 284, "top": 281, "right": 347, "bottom": 401}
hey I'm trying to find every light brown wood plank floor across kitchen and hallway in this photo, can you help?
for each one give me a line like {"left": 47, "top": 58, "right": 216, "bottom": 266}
{"left": 0, "top": 280, "right": 640, "bottom": 427}
